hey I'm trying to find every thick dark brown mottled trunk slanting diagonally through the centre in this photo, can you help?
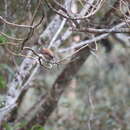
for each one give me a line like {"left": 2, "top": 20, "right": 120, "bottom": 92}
{"left": 22, "top": 47, "right": 90, "bottom": 128}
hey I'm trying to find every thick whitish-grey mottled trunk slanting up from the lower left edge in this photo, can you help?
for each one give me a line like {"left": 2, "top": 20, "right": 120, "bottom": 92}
{"left": 0, "top": 0, "right": 68, "bottom": 125}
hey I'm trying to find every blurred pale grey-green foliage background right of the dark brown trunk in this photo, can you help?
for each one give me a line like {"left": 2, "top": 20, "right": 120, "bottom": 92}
{"left": 43, "top": 43, "right": 130, "bottom": 130}
